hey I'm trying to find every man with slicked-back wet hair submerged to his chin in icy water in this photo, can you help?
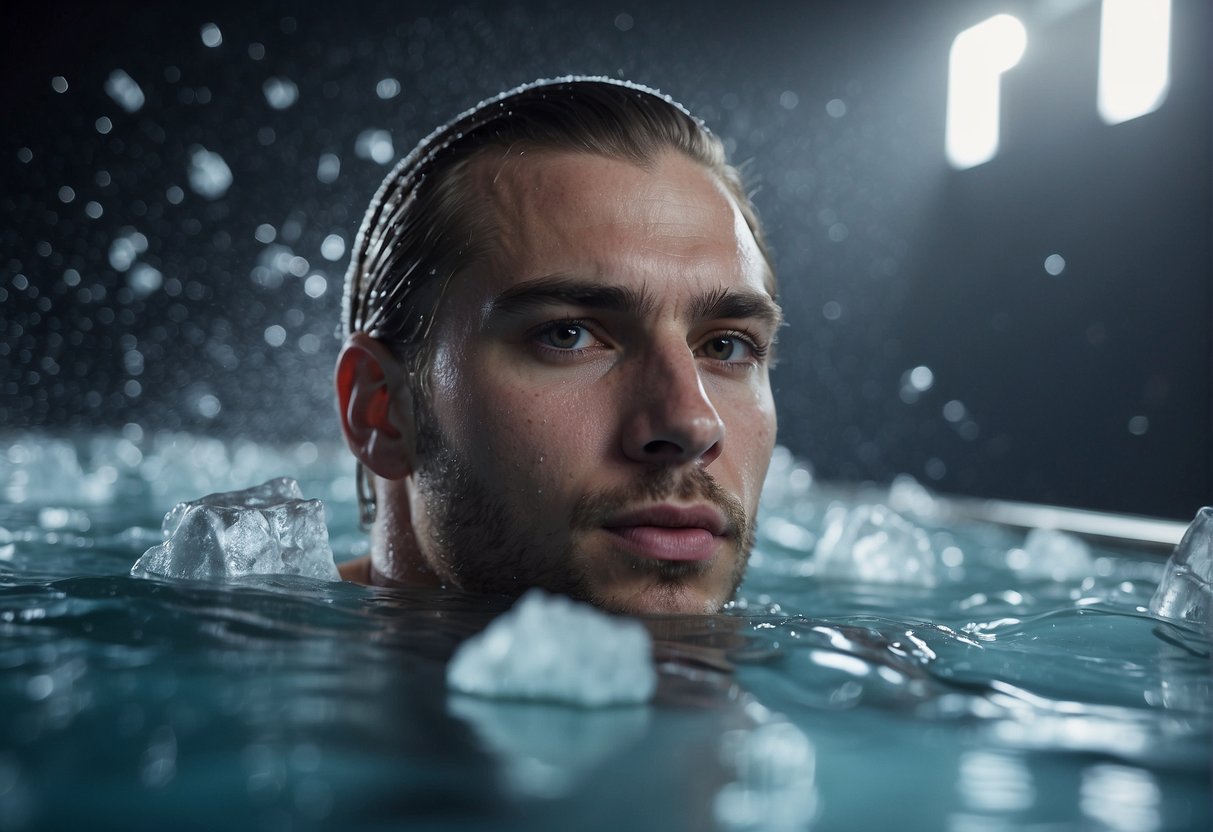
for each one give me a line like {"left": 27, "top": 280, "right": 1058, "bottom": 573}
{"left": 336, "top": 79, "right": 781, "bottom": 612}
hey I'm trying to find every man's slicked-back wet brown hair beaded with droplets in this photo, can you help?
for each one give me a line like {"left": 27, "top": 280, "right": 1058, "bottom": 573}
{"left": 342, "top": 78, "right": 775, "bottom": 524}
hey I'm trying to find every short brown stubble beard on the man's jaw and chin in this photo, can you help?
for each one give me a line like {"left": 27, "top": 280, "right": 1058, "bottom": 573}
{"left": 414, "top": 414, "right": 754, "bottom": 611}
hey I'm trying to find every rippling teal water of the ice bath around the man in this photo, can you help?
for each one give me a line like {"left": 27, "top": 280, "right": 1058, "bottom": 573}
{"left": 0, "top": 432, "right": 1213, "bottom": 832}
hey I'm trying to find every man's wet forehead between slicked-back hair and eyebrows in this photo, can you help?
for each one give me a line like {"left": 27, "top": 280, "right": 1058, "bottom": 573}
{"left": 457, "top": 149, "right": 769, "bottom": 306}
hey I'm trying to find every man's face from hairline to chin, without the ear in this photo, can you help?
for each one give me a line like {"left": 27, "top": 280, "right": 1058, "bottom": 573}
{"left": 409, "top": 152, "right": 779, "bottom": 612}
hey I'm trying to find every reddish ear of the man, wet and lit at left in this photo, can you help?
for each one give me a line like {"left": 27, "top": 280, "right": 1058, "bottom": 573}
{"left": 335, "top": 332, "right": 416, "bottom": 479}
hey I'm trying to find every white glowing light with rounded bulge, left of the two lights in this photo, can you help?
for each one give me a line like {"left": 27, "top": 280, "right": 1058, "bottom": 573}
{"left": 945, "top": 15, "right": 1027, "bottom": 170}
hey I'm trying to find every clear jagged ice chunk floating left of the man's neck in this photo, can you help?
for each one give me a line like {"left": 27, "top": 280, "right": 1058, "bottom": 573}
{"left": 131, "top": 477, "right": 340, "bottom": 581}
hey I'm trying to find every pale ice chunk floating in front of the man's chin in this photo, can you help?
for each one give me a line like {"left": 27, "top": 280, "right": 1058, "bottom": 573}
{"left": 446, "top": 589, "right": 657, "bottom": 707}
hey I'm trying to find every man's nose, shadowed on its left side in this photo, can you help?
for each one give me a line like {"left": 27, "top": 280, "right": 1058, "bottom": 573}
{"left": 623, "top": 344, "right": 724, "bottom": 466}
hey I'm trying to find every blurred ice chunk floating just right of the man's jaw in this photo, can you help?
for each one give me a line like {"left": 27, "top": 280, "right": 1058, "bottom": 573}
{"left": 815, "top": 506, "right": 939, "bottom": 587}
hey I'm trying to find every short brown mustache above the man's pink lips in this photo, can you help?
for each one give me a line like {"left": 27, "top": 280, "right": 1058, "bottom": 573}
{"left": 570, "top": 468, "right": 753, "bottom": 547}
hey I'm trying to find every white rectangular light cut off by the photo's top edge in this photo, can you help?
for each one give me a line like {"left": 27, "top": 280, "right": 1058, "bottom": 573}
{"left": 1098, "top": 0, "right": 1171, "bottom": 124}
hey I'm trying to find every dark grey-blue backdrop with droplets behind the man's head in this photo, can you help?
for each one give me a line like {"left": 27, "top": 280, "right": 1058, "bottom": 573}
{"left": 0, "top": 0, "right": 1213, "bottom": 519}
